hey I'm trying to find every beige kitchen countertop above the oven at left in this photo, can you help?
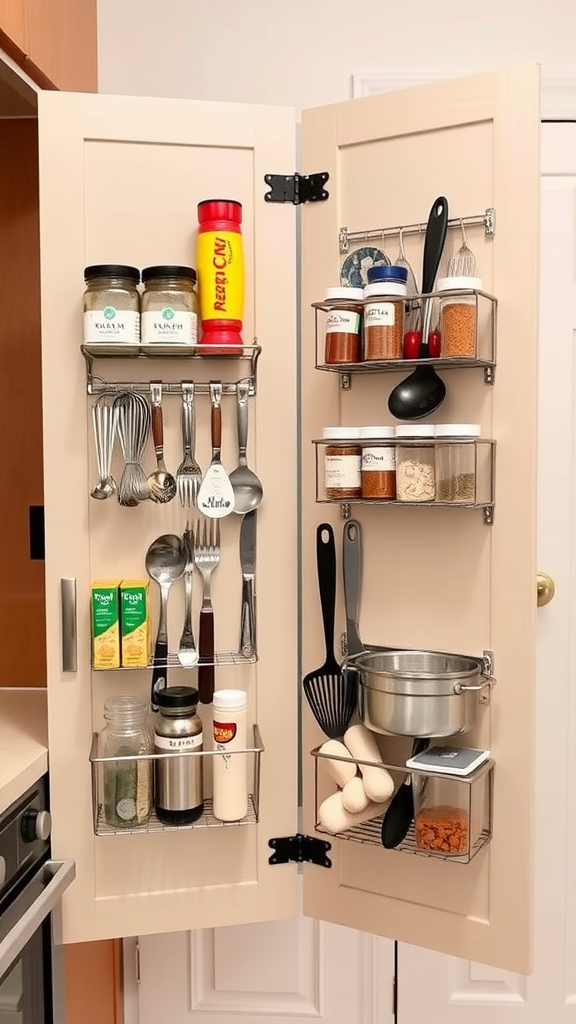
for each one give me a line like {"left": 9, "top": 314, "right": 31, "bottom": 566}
{"left": 0, "top": 688, "right": 48, "bottom": 813}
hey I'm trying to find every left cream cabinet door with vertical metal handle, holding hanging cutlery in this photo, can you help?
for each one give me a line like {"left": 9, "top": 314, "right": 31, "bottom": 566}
{"left": 39, "top": 93, "right": 297, "bottom": 942}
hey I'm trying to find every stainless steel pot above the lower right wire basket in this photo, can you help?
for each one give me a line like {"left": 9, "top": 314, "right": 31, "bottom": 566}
{"left": 346, "top": 650, "right": 491, "bottom": 737}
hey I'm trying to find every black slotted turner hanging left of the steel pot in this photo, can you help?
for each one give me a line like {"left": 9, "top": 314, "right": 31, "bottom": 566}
{"left": 302, "top": 522, "right": 358, "bottom": 739}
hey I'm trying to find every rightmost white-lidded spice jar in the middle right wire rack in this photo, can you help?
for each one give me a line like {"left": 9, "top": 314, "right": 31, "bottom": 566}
{"left": 435, "top": 423, "right": 480, "bottom": 505}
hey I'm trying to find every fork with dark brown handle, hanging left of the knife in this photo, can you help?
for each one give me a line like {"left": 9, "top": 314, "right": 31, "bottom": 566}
{"left": 194, "top": 519, "right": 220, "bottom": 703}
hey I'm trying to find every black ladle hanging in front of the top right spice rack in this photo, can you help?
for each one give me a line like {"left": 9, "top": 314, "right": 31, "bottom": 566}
{"left": 388, "top": 196, "right": 448, "bottom": 420}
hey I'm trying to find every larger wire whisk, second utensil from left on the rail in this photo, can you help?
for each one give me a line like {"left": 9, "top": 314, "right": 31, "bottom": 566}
{"left": 114, "top": 391, "right": 151, "bottom": 506}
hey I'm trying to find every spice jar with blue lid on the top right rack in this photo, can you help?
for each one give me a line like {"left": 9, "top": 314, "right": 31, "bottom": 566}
{"left": 364, "top": 264, "right": 408, "bottom": 361}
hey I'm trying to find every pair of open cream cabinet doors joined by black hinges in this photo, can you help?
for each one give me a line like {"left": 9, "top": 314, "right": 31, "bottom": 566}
{"left": 34, "top": 68, "right": 539, "bottom": 971}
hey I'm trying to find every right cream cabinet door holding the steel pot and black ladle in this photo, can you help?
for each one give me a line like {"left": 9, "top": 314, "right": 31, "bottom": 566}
{"left": 301, "top": 68, "right": 539, "bottom": 972}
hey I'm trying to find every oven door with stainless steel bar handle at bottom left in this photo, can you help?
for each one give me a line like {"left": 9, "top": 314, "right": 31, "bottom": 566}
{"left": 0, "top": 860, "right": 76, "bottom": 1024}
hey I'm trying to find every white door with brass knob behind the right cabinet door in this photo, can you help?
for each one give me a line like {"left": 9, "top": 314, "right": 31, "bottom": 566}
{"left": 398, "top": 123, "right": 576, "bottom": 1024}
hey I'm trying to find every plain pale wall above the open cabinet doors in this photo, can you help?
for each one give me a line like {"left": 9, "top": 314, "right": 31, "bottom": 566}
{"left": 98, "top": 0, "right": 576, "bottom": 108}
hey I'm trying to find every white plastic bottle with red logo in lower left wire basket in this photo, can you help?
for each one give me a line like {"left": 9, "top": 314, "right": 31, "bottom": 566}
{"left": 212, "top": 690, "right": 248, "bottom": 821}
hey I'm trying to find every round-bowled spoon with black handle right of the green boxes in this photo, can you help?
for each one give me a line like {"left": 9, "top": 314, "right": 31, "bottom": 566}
{"left": 146, "top": 534, "right": 187, "bottom": 710}
